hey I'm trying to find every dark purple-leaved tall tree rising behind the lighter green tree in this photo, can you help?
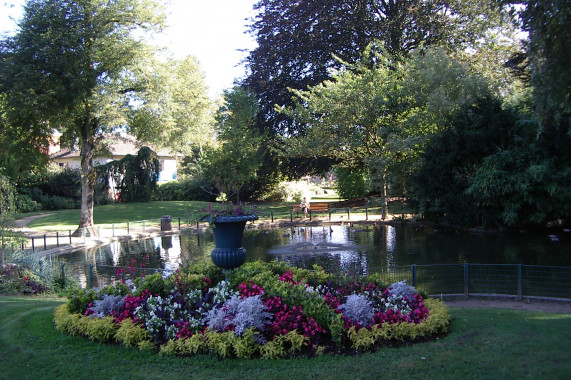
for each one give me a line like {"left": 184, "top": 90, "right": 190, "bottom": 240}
{"left": 244, "top": 0, "right": 524, "bottom": 180}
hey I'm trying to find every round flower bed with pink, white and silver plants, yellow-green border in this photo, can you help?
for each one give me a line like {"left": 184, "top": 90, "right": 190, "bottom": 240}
{"left": 55, "top": 262, "right": 449, "bottom": 358}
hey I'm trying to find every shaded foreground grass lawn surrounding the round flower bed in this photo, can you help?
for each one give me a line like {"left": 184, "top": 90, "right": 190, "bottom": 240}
{"left": 0, "top": 297, "right": 571, "bottom": 379}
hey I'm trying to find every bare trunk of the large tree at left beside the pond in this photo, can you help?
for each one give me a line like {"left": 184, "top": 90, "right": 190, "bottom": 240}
{"left": 73, "top": 136, "right": 97, "bottom": 236}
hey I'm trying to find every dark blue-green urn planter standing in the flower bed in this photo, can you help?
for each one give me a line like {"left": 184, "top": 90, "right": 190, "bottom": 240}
{"left": 210, "top": 215, "right": 258, "bottom": 269}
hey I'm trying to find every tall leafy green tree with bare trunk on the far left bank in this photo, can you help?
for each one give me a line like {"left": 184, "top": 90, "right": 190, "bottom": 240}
{"left": 0, "top": 0, "right": 211, "bottom": 234}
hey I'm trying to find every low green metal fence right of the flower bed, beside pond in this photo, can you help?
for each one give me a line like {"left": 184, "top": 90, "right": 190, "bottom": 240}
{"left": 371, "top": 263, "right": 571, "bottom": 300}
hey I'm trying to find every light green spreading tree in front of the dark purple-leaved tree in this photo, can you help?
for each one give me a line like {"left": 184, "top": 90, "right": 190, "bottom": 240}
{"left": 281, "top": 45, "right": 486, "bottom": 214}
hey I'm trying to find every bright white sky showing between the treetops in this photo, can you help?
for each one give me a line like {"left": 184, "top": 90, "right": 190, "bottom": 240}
{"left": 0, "top": 0, "right": 257, "bottom": 99}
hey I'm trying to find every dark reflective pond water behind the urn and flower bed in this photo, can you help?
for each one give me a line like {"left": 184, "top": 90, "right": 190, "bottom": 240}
{"left": 54, "top": 224, "right": 571, "bottom": 286}
